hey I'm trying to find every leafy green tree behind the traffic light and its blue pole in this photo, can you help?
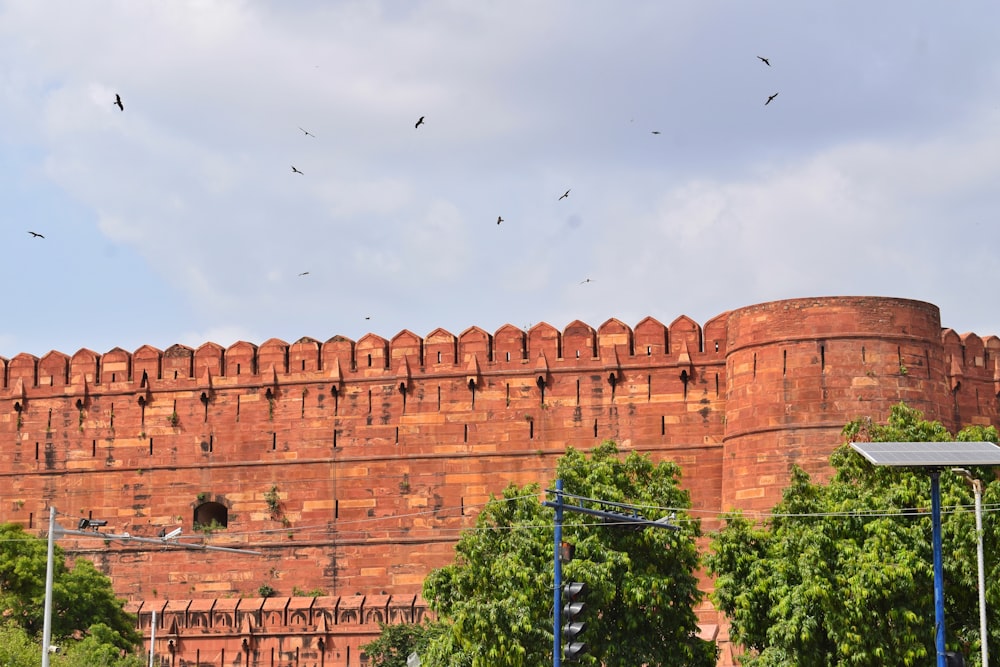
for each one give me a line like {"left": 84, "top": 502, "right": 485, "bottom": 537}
{"left": 421, "top": 442, "right": 716, "bottom": 667}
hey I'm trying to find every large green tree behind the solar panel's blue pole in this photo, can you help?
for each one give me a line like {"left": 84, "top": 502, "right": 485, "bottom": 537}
{"left": 707, "top": 404, "right": 1000, "bottom": 667}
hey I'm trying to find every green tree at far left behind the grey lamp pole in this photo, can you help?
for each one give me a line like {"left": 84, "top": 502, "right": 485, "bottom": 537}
{"left": 0, "top": 523, "right": 140, "bottom": 651}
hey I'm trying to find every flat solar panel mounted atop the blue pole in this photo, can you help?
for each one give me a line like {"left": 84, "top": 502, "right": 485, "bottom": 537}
{"left": 851, "top": 442, "right": 1000, "bottom": 468}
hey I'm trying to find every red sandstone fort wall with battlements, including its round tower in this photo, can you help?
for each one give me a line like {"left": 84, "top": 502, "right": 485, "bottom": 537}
{"left": 0, "top": 297, "right": 1000, "bottom": 665}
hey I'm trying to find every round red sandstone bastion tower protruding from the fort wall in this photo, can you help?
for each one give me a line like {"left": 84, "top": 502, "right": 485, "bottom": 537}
{"left": 722, "top": 297, "right": 952, "bottom": 511}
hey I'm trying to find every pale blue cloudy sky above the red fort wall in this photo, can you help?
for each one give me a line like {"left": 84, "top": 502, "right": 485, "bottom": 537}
{"left": 0, "top": 0, "right": 1000, "bottom": 358}
